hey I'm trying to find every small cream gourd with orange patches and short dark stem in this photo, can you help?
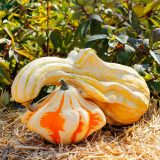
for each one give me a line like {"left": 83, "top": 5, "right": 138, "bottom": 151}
{"left": 22, "top": 80, "right": 106, "bottom": 144}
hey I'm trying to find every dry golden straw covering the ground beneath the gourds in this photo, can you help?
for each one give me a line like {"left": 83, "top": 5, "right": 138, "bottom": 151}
{"left": 0, "top": 99, "right": 160, "bottom": 160}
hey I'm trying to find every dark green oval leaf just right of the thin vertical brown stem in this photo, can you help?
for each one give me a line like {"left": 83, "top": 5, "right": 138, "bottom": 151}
{"left": 50, "top": 30, "right": 63, "bottom": 49}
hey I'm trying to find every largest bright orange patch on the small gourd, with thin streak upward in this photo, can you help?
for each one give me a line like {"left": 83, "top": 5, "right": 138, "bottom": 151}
{"left": 40, "top": 94, "right": 65, "bottom": 143}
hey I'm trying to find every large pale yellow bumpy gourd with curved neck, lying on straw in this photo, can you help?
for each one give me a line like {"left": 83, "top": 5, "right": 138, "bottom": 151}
{"left": 12, "top": 48, "right": 150, "bottom": 125}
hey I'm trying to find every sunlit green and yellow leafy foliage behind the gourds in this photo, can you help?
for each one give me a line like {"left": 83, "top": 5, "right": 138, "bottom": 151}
{"left": 0, "top": 0, "right": 160, "bottom": 105}
